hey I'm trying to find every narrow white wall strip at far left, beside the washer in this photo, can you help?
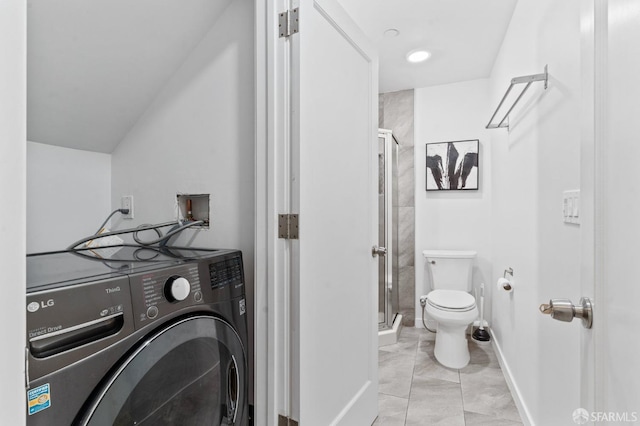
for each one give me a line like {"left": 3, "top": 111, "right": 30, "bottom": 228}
{"left": 0, "top": 0, "right": 27, "bottom": 425}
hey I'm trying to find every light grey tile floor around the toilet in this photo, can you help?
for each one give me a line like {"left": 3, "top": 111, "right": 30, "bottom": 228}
{"left": 374, "top": 327, "right": 522, "bottom": 426}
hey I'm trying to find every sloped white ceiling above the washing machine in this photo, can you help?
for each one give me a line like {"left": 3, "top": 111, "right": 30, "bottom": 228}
{"left": 27, "top": 0, "right": 231, "bottom": 153}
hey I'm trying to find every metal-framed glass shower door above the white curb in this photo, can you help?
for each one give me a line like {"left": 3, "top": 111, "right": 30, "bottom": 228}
{"left": 377, "top": 129, "right": 399, "bottom": 330}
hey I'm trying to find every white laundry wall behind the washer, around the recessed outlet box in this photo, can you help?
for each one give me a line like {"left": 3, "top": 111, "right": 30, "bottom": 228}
{"left": 111, "top": 0, "right": 256, "bottom": 400}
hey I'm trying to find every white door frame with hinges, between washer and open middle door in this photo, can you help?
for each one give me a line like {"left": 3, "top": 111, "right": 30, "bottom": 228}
{"left": 254, "top": 0, "right": 291, "bottom": 426}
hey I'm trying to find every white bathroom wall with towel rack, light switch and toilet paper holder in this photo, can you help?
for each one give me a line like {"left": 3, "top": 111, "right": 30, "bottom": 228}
{"left": 486, "top": 0, "right": 581, "bottom": 425}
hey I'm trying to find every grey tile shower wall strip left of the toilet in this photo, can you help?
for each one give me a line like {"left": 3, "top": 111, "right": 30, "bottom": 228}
{"left": 378, "top": 90, "right": 415, "bottom": 327}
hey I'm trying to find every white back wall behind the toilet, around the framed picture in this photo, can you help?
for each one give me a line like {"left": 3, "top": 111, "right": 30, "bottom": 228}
{"left": 415, "top": 79, "right": 495, "bottom": 327}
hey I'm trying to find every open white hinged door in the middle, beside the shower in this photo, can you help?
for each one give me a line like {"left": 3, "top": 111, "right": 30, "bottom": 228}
{"left": 290, "top": 0, "right": 378, "bottom": 426}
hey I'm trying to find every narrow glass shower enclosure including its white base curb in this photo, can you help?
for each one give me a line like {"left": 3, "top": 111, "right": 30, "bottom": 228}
{"left": 378, "top": 129, "right": 401, "bottom": 345}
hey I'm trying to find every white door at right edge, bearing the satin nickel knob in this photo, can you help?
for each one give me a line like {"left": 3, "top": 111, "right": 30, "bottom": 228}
{"left": 574, "top": 0, "right": 640, "bottom": 425}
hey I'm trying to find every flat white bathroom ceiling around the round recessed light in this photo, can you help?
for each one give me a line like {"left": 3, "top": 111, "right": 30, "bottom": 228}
{"left": 338, "top": 0, "right": 517, "bottom": 93}
